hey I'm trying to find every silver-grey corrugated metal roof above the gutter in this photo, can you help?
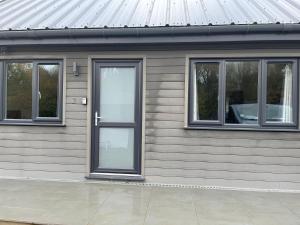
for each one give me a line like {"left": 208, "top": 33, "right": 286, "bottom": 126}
{"left": 0, "top": 0, "right": 300, "bottom": 30}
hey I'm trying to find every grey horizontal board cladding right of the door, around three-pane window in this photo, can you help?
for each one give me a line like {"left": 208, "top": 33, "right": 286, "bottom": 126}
{"left": 145, "top": 51, "right": 300, "bottom": 189}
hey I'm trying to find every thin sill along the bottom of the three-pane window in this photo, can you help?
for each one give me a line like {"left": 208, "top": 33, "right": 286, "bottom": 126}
{"left": 184, "top": 126, "right": 300, "bottom": 133}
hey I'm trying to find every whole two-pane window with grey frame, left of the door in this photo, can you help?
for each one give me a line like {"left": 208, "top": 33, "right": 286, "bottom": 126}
{"left": 0, "top": 60, "right": 62, "bottom": 124}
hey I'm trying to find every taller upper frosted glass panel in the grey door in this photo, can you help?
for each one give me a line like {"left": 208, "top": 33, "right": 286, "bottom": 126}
{"left": 100, "top": 67, "right": 136, "bottom": 122}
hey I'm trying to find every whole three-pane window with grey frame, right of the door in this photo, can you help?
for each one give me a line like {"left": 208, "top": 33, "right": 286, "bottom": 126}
{"left": 188, "top": 59, "right": 298, "bottom": 129}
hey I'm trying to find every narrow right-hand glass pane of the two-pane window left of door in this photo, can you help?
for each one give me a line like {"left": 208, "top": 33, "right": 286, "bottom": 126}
{"left": 38, "top": 64, "right": 59, "bottom": 117}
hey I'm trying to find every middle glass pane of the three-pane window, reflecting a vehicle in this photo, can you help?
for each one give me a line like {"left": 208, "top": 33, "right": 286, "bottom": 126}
{"left": 225, "top": 61, "right": 258, "bottom": 124}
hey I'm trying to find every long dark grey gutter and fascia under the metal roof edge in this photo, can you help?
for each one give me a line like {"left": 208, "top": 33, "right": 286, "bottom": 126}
{"left": 0, "top": 24, "right": 300, "bottom": 46}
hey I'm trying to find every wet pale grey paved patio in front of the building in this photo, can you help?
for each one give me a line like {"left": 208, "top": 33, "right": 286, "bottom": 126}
{"left": 0, "top": 180, "right": 300, "bottom": 225}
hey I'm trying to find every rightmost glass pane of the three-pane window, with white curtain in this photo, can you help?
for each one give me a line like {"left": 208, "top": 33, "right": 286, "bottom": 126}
{"left": 266, "top": 63, "right": 293, "bottom": 123}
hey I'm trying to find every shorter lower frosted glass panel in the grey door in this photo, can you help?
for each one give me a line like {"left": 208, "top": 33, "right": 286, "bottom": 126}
{"left": 99, "top": 128, "right": 134, "bottom": 170}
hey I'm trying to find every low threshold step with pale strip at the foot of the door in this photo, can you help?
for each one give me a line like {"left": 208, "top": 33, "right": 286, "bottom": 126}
{"left": 86, "top": 173, "right": 145, "bottom": 181}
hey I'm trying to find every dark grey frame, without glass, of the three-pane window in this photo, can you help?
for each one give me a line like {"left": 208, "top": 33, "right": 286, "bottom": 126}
{"left": 187, "top": 57, "right": 300, "bottom": 131}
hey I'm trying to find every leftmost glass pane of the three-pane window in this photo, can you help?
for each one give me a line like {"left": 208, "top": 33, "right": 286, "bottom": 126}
{"left": 194, "top": 62, "right": 219, "bottom": 120}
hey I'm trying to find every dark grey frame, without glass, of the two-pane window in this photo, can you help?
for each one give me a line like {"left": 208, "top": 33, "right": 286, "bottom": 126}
{"left": 0, "top": 59, "right": 63, "bottom": 125}
